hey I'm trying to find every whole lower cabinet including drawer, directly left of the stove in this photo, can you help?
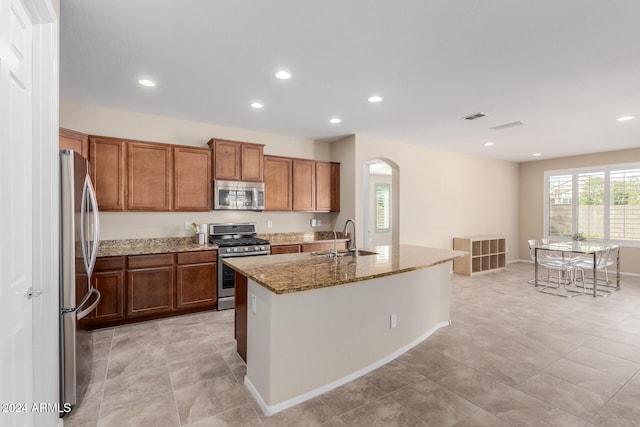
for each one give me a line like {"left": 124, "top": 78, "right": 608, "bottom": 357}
{"left": 176, "top": 251, "right": 217, "bottom": 309}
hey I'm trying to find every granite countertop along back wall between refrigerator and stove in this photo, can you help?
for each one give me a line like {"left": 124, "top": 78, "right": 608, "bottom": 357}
{"left": 98, "top": 237, "right": 218, "bottom": 257}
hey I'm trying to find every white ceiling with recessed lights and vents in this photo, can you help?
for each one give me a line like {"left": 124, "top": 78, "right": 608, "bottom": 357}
{"left": 60, "top": 0, "right": 640, "bottom": 161}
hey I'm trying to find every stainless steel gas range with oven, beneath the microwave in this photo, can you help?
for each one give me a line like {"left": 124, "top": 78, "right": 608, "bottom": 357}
{"left": 209, "top": 223, "right": 271, "bottom": 310}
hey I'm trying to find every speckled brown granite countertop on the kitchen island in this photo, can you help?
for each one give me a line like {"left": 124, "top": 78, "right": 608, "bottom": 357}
{"left": 224, "top": 245, "right": 466, "bottom": 294}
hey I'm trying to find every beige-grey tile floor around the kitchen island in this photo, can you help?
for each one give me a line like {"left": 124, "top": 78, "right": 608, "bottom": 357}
{"left": 65, "top": 263, "right": 640, "bottom": 427}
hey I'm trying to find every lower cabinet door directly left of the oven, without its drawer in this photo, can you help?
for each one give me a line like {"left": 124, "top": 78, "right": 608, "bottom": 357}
{"left": 176, "top": 262, "right": 217, "bottom": 309}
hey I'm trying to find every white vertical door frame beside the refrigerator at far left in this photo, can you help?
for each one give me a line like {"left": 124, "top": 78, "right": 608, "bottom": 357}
{"left": 28, "top": 0, "right": 62, "bottom": 426}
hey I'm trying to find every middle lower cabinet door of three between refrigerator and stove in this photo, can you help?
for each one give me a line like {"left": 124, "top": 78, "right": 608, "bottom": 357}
{"left": 127, "top": 265, "right": 175, "bottom": 317}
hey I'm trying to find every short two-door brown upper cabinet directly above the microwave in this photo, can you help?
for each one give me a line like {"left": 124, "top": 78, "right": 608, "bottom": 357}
{"left": 207, "top": 138, "right": 264, "bottom": 182}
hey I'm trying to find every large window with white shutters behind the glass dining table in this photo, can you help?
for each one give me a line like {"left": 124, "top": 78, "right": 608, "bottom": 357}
{"left": 545, "top": 164, "right": 640, "bottom": 246}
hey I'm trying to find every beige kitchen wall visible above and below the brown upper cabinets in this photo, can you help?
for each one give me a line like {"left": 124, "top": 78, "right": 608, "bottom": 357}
{"left": 60, "top": 103, "right": 336, "bottom": 240}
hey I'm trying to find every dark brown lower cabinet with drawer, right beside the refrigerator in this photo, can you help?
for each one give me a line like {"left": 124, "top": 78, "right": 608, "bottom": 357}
{"left": 91, "top": 256, "right": 125, "bottom": 324}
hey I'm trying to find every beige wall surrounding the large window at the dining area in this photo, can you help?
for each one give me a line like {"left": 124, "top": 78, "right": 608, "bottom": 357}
{"left": 518, "top": 148, "right": 640, "bottom": 274}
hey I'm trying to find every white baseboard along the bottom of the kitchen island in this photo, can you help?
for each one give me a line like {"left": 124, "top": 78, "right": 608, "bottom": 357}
{"left": 244, "top": 320, "right": 451, "bottom": 417}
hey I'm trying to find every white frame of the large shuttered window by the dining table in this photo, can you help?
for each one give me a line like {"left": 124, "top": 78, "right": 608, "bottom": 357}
{"left": 543, "top": 162, "right": 640, "bottom": 247}
